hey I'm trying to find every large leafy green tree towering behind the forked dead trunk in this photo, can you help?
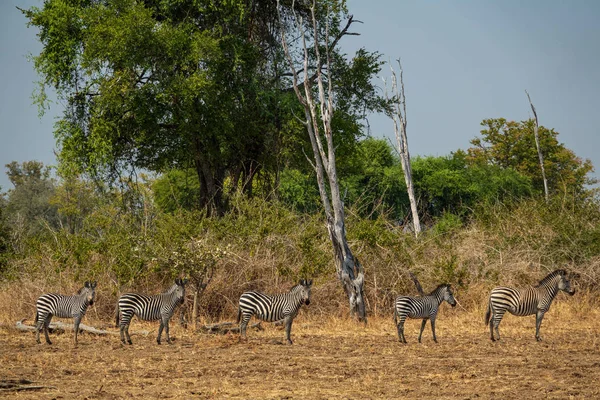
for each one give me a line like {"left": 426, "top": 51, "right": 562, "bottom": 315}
{"left": 23, "top": 0, "right": 379, "bottom": 214}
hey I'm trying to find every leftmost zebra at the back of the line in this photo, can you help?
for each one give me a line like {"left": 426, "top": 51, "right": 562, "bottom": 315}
{"left": 35, "top": 282, "right": 97, "bottom": 346}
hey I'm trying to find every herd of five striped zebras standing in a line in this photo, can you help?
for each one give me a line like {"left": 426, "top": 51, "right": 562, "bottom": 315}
{"left": 35, "top": 269, "right": 575, "bottom": 345}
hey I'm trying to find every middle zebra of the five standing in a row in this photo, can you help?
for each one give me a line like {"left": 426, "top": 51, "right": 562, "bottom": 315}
{"left": 237, "top": 279, "right": 312, "bottom": 344}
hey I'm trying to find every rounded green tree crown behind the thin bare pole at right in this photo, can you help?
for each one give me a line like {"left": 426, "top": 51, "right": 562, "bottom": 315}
{"left": 468, "top": 118, "right": 595, "bottom": 194}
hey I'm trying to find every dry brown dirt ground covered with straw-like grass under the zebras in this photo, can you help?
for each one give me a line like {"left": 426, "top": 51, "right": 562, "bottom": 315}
{"left": 0, "top": 305, "right": 600, "bottom": 399}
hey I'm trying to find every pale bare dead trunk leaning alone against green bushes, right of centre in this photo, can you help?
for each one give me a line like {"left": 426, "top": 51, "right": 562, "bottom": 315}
{"left": 383, "top": 59, "right": 421, "bottom": 237}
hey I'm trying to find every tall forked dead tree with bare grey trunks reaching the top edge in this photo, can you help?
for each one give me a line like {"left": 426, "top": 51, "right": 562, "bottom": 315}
{"left": 277, "top": 0, "right": 367, "bottom": 323}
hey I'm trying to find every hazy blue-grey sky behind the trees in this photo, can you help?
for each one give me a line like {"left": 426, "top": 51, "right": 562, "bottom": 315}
{"left": 0, "top": 0, "right": 600, "bottom": 190}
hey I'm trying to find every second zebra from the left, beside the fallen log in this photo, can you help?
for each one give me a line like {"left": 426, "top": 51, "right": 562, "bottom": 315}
{"left": 116, "top": 278, "right": 187, "bottom": 344}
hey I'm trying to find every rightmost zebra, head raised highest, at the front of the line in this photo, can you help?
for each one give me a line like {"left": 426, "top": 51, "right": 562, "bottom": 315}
{"left": 485, "top": 269, "right": 575, "bottom": 342}
